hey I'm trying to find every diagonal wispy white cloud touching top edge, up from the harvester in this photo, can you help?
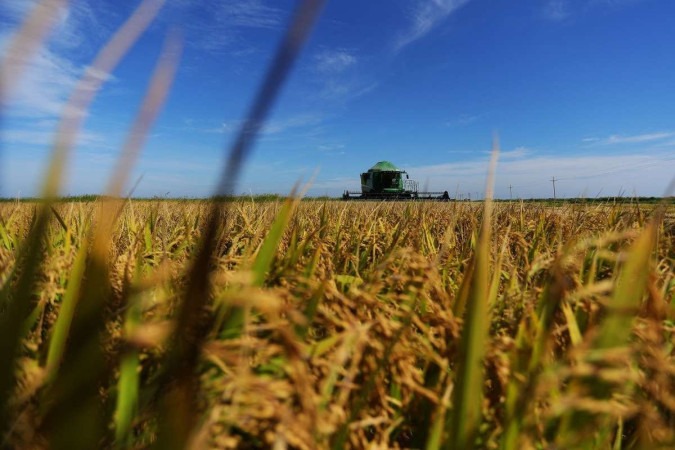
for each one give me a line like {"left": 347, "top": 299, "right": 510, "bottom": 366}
{"left": 394, "top": 0, "right": 470, "bottom": 52}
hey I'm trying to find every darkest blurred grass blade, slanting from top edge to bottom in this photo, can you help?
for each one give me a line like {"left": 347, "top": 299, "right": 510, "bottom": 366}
{"left": 156, "top": 0, "right": 323, "bottom": 449}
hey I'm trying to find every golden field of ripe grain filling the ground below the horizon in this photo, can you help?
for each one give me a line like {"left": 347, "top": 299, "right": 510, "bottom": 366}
{"left": 0, "top": 200, "right": 675, "bottom": 449}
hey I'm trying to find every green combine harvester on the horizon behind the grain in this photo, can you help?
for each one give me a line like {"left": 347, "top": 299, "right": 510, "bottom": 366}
{"left": 342, "top": 161, "right": 450, "bottom": 201}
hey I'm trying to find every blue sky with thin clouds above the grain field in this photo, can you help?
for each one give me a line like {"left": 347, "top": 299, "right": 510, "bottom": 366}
{"left": 0, "top": 0, "right": 675, "bottom": 198}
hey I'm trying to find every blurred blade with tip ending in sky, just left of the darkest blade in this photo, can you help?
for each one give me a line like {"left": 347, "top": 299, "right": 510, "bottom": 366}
{"left": 45, "top": 11, "right": 175, "bottom": 449}
